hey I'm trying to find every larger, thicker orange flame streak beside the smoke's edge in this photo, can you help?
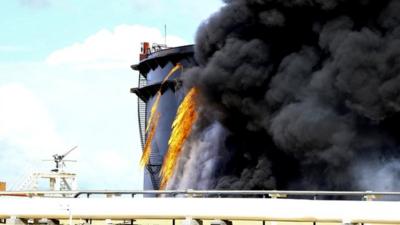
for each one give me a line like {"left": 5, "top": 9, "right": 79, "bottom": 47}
{"left": 160, "top": 88, "right": 198, "bottom": 189}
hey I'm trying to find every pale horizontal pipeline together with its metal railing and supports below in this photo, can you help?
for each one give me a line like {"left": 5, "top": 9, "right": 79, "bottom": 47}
{"left": 0, "top": 190, "right": 400, "bottom": 225}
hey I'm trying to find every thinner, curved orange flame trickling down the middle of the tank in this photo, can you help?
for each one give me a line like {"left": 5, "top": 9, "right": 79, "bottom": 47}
{"left": 140, "top": 63, "right": 183, "bottom": 166}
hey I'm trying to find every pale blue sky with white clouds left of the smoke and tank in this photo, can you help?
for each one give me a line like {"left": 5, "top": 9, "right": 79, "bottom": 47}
{"left": 0, "top": 0, "right": 222, "bottom": 189}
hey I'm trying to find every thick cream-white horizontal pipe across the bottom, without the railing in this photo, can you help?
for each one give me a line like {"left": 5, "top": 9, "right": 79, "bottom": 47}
{"left": 0, "top": 197, "right": 400, "bottom": 224}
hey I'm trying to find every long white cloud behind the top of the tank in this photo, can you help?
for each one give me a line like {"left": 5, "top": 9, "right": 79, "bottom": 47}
{"left": 46, "top": 25, "right": 187, "bottom": 69}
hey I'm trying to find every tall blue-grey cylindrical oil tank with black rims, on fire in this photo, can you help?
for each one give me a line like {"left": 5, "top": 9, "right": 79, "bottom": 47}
{"left": 131, "top": 42, "right": 195, "bottom": 190}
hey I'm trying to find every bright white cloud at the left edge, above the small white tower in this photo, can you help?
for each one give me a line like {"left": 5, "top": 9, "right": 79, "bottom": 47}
{"left": 0, "top": 84, "right": 63, "bottom": 156}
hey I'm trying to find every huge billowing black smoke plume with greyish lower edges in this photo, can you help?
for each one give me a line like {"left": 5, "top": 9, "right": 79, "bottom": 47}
{"left": 169, "top": 0, "right": 400, "bottom": 191}
